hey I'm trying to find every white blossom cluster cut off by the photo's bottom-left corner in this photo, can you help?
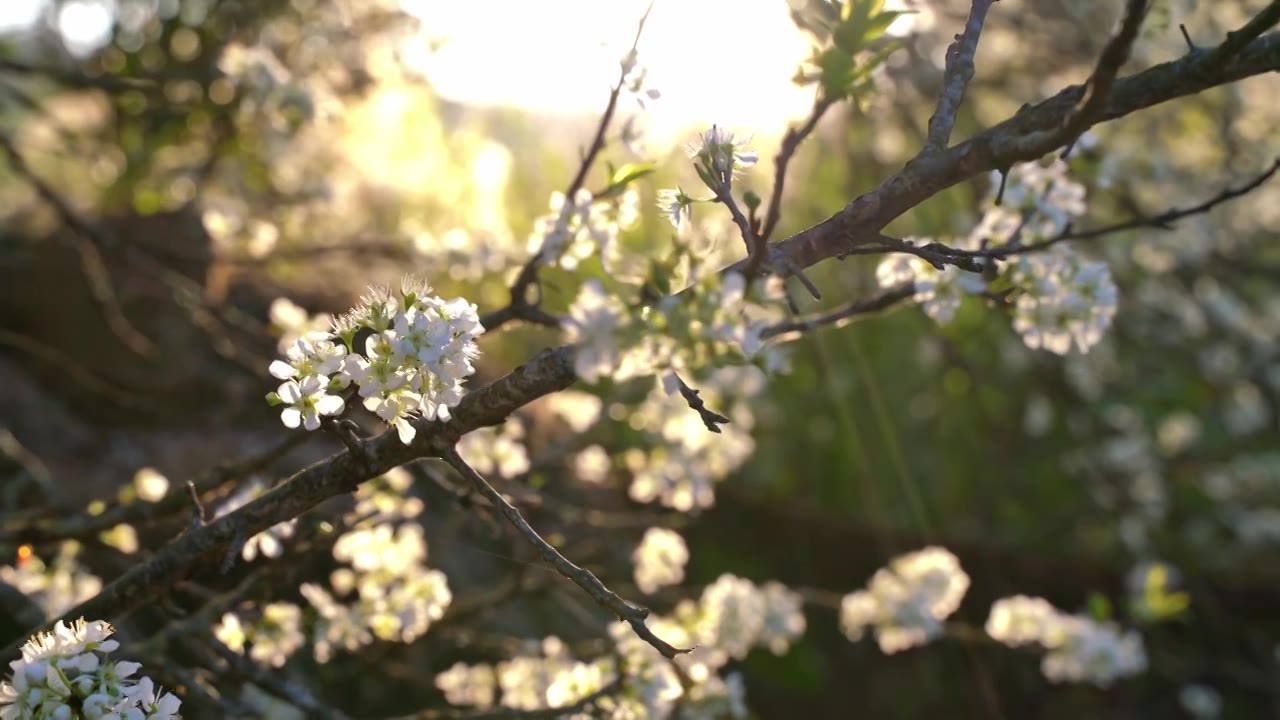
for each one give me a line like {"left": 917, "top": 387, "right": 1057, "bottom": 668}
{"left": 0, "top": 618, "right": 182, "bottom": 720}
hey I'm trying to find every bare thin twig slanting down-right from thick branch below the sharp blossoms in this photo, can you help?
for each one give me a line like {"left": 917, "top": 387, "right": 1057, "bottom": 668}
{"left": 438, "top": 446, "right": 691, "bottom": 659}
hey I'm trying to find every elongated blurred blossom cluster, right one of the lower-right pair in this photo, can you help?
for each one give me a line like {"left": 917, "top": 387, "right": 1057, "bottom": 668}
{"left": 987, "top": 596, "right": 1147, "bottom": 688}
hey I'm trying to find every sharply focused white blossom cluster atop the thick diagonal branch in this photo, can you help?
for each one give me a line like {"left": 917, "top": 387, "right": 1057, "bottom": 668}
{"left": 268, "top": 278, "right": 484, "bottom": 443}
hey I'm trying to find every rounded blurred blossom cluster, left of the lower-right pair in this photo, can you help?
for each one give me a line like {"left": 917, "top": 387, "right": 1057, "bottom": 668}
{"left": 840, "top": 546, "right": 969, "bottom": 655}
